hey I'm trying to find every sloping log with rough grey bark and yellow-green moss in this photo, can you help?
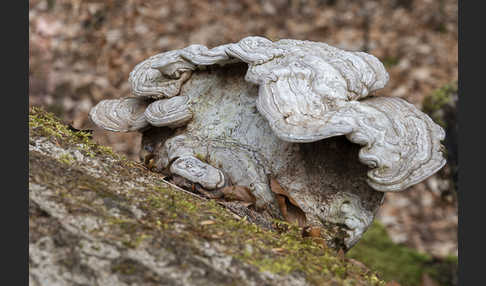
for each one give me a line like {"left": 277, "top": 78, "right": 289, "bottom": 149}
{"left": 29, "top": 109, "right": 385, "bottom": 285}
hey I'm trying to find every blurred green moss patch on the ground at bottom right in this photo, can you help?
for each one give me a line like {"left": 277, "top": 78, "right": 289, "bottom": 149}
{"left": 347, "top": 221, "right": 457, "bottom": 286}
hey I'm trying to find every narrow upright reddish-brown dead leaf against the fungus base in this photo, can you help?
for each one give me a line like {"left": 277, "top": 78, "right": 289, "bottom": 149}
{"left": 270, "top": 178, "right": 307, "bottom": 226}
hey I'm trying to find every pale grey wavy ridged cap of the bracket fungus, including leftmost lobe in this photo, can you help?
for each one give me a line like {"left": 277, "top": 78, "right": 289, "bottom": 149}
{"left": 90, "top": 37, "right": 445, "bottom": 191}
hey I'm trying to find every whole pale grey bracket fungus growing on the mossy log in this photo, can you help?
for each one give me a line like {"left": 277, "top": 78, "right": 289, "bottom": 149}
{"left": 90, "top": 37, "right": 445, "bottom": 249}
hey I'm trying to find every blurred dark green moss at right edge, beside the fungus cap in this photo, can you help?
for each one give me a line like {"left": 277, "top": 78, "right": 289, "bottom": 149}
{"left": 422, "top": 82, "right": 457, "bottom": 128}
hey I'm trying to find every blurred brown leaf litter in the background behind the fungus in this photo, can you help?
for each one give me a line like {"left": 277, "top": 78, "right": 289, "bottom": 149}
{"left": 29, "top": 0, "right": 458, "bottom": 257}
